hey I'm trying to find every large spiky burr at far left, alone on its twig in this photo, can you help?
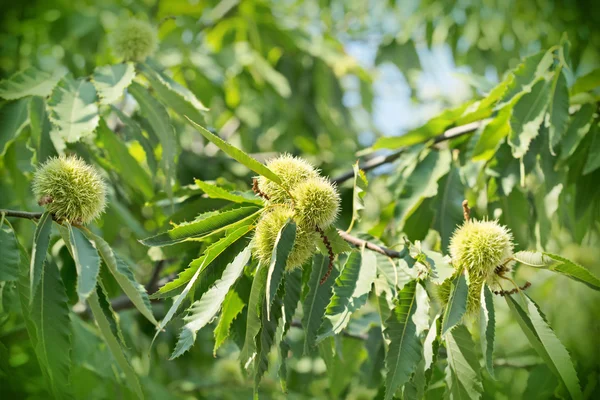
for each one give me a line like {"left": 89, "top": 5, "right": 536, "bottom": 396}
{"left": 33, "top": 156, "right": 106, "bottom": 224}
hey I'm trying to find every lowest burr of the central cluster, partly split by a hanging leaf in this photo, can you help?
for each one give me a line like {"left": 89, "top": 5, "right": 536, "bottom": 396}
{"left": 252, "top": 207, "right": 319, "bottom": 270}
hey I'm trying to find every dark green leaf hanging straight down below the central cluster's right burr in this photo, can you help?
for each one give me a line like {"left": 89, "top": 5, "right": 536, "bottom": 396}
{"left": 302, "top": 254, "right": 338, "bottom": 354}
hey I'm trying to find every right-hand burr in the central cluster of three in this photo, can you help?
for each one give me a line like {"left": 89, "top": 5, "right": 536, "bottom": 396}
{"left": 292, "top": 177, "right": 340, "bottom": 229}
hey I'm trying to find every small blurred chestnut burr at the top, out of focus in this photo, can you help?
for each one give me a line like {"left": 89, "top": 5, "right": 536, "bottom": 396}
{"left": 112, "top": 19, "right": 158, "bottom": 62}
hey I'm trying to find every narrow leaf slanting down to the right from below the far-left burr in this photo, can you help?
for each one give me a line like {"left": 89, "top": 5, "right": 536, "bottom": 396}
{"left": 82, "top": 228, "right": 158, "bottom": 325}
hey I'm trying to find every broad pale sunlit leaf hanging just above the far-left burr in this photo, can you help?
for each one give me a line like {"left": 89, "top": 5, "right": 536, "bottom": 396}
{"left": 48, "top": 74, "right": 100, "bottom": 143}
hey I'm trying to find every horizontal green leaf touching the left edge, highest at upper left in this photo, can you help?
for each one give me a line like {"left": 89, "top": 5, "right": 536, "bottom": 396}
{"left": 0, "top": 67, "right": 65, "bottom": 100}
